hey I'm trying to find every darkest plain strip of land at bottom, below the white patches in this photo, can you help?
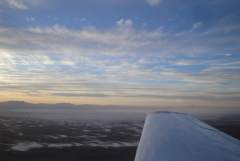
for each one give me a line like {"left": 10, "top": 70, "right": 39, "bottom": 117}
{"left": 0, "top": 147, "right": 136, "bottom": 161}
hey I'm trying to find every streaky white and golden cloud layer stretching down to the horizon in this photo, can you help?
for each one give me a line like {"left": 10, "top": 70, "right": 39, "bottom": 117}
{"left": 0, "top": 0, "right": 240, "bottom": 107}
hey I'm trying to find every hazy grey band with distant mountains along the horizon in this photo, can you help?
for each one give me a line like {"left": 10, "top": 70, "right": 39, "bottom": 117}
{"left": 0, "top": 101, "right": 240, "bottom": 117}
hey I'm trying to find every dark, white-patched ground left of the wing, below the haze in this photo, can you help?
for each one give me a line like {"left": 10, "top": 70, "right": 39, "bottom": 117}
{"left": 0, "top": 117, "right": 143, "bottom": 161}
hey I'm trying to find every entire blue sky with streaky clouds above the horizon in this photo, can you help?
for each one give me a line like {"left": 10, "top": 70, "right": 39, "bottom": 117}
{"left": 0, "top": 0, "right": 240, "bottom": 108}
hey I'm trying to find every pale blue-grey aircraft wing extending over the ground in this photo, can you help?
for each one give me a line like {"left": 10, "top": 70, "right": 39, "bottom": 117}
{"left": 135, "top": 112, "right": 240, "bottom": 161}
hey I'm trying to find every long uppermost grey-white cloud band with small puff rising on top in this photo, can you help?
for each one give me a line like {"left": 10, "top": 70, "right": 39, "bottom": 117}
{"left": 0, "top": 19, "right": 234, "bottom": 60}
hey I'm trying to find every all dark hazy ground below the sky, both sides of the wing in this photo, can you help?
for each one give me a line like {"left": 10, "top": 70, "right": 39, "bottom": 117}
{"left": 0, "top": 103, "right": 240, "bottom": 161}
